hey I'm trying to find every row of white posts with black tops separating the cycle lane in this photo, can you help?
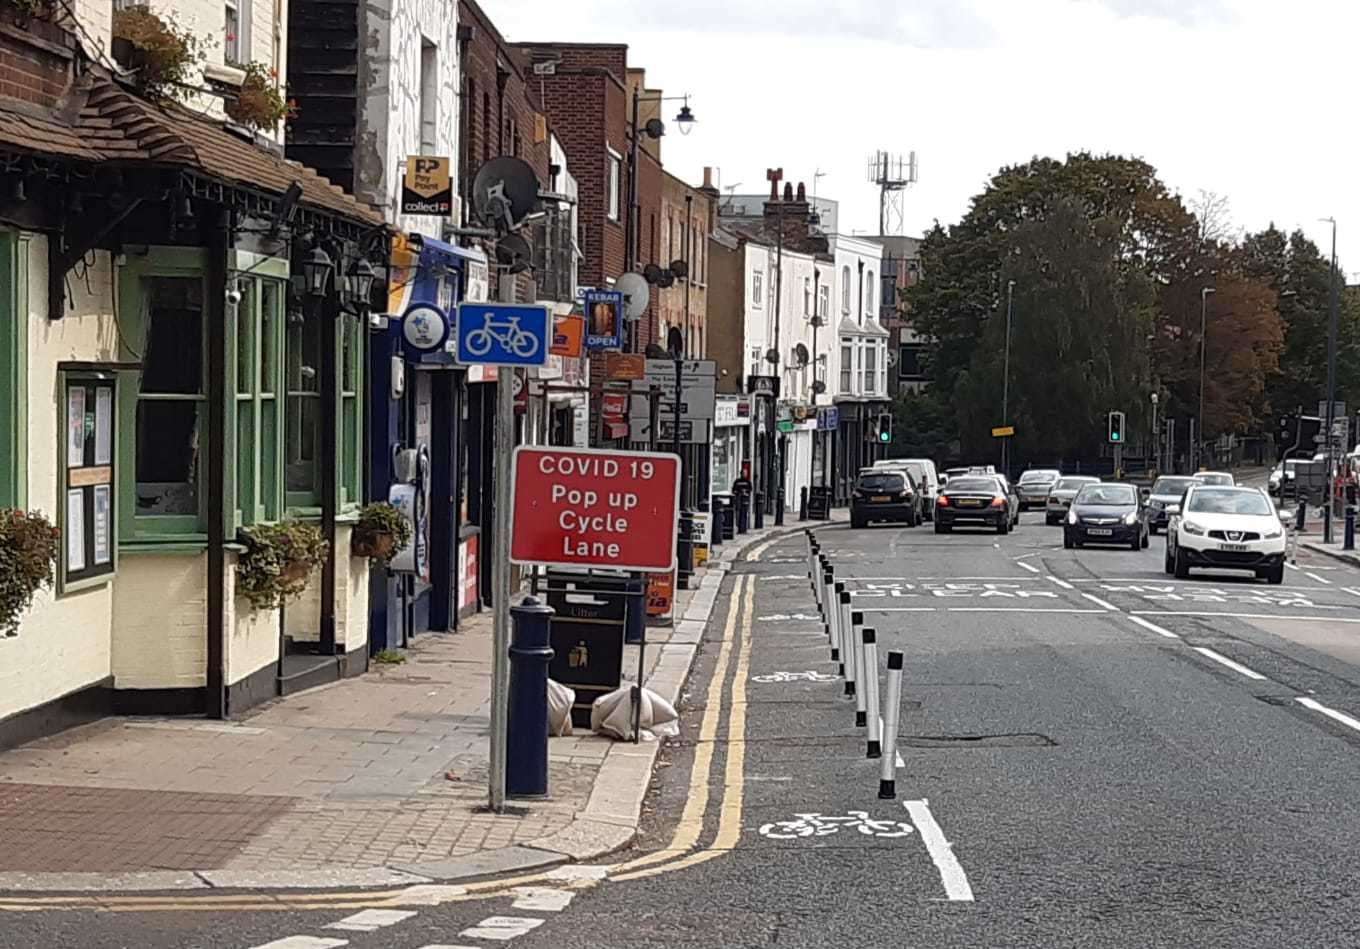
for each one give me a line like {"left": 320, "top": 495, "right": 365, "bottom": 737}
{"left": 804, "top": 528, "right": 903, "bottom": 799}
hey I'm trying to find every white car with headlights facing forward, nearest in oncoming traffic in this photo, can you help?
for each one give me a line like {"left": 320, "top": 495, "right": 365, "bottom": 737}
{"left": 1164, "top": 484, "right": 1287, "bottom": 583}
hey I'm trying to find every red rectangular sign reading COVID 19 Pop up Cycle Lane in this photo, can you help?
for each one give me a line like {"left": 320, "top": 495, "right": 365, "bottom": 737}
{"left": 510, "top": 445, "right": 680, "bottom": 572}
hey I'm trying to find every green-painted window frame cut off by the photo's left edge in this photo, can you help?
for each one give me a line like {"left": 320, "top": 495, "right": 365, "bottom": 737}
{"left": 0, "top": 230, "right": 29, "bottom": 507}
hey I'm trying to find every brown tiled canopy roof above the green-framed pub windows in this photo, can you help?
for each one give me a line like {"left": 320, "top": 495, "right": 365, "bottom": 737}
{"left": 0, "top": 73, "right": 382, "bottom": 224}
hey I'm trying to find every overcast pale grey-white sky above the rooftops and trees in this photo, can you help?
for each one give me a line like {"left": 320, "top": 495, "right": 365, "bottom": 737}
{"left": 500, "top": 0, "right": 1360, "bottom": 273}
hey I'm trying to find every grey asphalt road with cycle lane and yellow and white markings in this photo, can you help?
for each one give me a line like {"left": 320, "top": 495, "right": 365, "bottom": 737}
{"left": 13, "top": 514, "right": 1360, "bottom": 949}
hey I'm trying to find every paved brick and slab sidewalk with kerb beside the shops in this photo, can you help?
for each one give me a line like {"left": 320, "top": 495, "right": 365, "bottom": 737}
{"left": 0, "top": 521, "right": 801, "bottom": 891}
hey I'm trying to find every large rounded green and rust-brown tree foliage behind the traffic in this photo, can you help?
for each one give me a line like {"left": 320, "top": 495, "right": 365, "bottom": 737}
{"left": 899, "top": 154, "right": 1284, "bottom": 462}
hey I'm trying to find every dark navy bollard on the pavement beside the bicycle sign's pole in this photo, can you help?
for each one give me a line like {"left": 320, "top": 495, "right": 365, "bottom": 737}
{"left": 506, "top": 597, "right": 554, "bottom": 798}
